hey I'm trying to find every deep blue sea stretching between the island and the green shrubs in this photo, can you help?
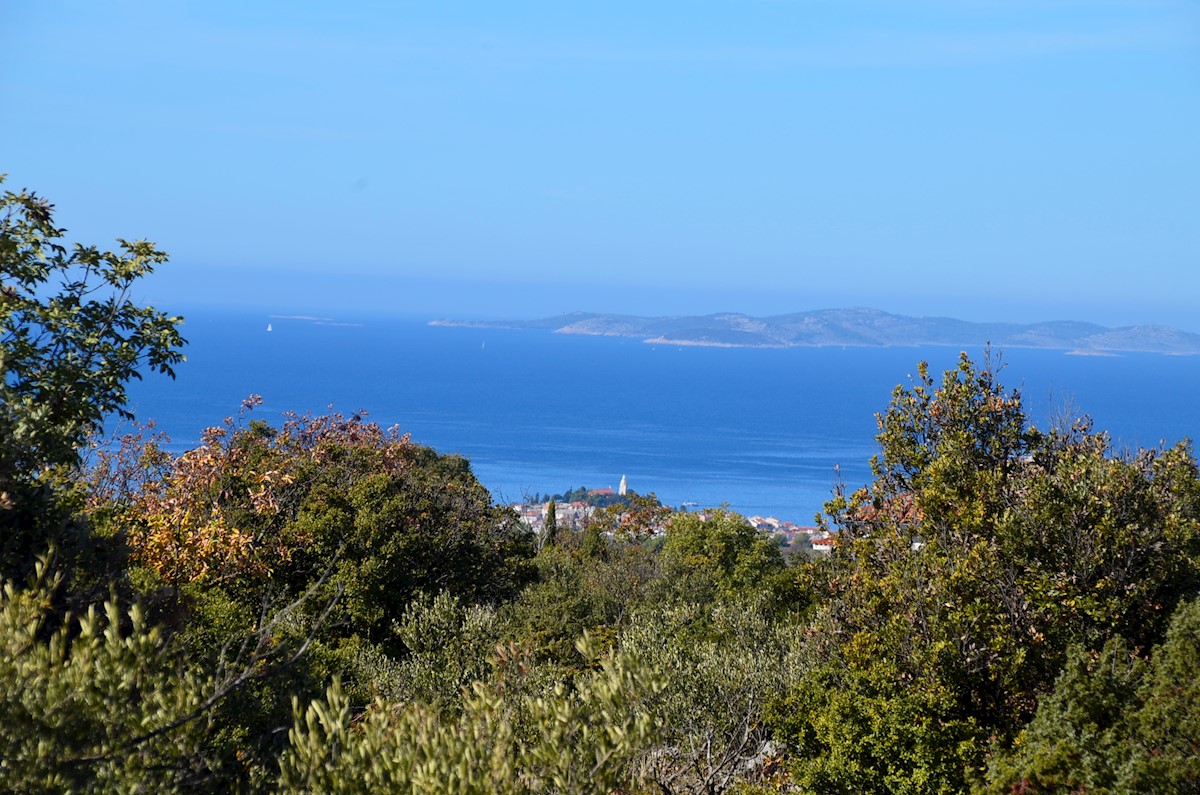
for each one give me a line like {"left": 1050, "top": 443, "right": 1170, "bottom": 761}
{"left": 121, "top": 310, "right": 1200, "bottom": 525}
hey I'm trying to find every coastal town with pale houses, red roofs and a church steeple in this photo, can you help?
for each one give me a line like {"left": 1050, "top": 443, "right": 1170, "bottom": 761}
{"left": 509, "top": 476, "right": 833, "bottom": 555}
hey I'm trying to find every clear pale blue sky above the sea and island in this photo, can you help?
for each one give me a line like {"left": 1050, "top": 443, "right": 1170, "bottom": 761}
{"left": 0, "top": 0, "right": 1200, "bottom": 331}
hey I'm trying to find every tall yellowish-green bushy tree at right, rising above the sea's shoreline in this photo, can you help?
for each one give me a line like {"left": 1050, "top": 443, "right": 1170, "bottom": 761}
{"left": 773, "top": 355, "right": 1200, "bottom": 791}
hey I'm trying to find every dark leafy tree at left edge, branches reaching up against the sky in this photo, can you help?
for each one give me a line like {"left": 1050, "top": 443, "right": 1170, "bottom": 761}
{"left": 0, "top": 177, "right": 184, "bottom": 579}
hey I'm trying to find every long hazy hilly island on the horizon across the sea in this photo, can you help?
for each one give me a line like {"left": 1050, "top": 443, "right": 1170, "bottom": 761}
{"left": 430, "top": 307, "right": 1200, "bottom": 355}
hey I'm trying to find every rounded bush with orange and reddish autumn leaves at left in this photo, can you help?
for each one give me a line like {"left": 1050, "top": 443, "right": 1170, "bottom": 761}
{"left": 125, "top": 400, "right": 532, "bottom": 651}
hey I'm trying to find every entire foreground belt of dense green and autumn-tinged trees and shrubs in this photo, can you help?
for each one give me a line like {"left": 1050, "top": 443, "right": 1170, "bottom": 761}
{"left": 0, "top": 182, "right": 1200, "bottom": 794}
